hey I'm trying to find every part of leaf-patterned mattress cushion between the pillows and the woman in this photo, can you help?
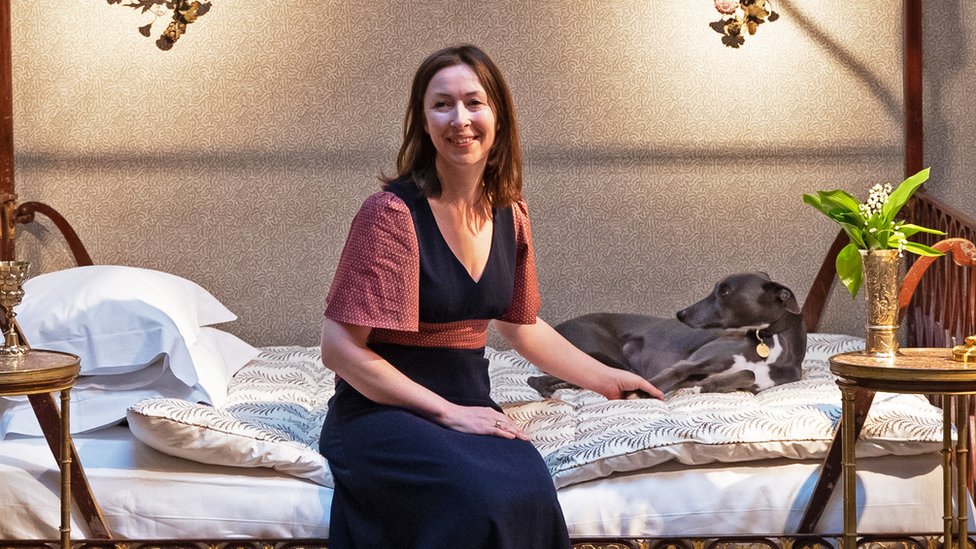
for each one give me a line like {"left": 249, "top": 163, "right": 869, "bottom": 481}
{"left": 126, "top": 347, "right": 335, "bottom": 486}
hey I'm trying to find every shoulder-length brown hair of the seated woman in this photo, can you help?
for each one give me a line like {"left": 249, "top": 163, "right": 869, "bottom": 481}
{"left": 387, "top": 44, "right": 522, "bottom": 207}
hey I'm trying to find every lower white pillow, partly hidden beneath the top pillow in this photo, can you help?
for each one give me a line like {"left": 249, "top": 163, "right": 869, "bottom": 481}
{"left": 0, "top": 327, "right": 258, "bottom": 439}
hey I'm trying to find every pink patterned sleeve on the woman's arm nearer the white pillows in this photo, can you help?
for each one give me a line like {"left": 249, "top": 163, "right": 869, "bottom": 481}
{"left": 325, "top": 192, "right": 420, "bottom": 332}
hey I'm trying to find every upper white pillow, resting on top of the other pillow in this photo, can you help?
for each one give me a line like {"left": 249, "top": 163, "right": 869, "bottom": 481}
{"left": 15, "top": 265, "right": 237, "bottom": 386}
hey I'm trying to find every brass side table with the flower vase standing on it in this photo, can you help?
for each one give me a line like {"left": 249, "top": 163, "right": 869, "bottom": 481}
{"left": 830, "top": 348, "right": 976, "bottom": 549}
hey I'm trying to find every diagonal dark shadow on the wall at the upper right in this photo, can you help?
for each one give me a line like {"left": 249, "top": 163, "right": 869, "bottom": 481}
{"left": 776, "top": 0, "right": 904, "bottom": 125}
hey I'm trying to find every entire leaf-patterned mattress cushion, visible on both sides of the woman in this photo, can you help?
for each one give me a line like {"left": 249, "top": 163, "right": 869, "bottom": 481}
{"left": 128, "top": 334, "right": 942, "bottom": 486}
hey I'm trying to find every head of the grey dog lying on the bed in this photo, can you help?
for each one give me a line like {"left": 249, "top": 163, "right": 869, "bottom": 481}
{"left": 677, "top": 272, "right": 800, "bottom": 329}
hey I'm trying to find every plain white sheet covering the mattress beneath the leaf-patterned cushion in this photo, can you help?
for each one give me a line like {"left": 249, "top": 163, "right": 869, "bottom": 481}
{"left": 0, "top": 427, "right": 960, "bottom": 539}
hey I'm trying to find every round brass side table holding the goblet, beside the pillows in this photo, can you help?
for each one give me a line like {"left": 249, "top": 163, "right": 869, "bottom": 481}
{"left": 0, "top": 349, "right": 81, "bottom": 549}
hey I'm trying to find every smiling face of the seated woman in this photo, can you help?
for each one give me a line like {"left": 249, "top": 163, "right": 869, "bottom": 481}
{"left": 424, "top": 64, "right": 495, "bottom": 176}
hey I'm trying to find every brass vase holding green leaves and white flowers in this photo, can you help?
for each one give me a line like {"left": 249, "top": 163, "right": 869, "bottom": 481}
{"left": 861, "top": 250, "right": 902, "bottom": 358}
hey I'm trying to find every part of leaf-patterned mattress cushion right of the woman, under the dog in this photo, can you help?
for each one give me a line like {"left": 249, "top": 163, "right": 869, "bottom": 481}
{"left": 489, "top": 333, "right": 942, "bottom": 486}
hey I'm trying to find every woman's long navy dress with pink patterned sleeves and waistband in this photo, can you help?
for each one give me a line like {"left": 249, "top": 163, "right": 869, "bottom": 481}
{"left": 320, "top": 180, "right": 570, "bottom": 549}
